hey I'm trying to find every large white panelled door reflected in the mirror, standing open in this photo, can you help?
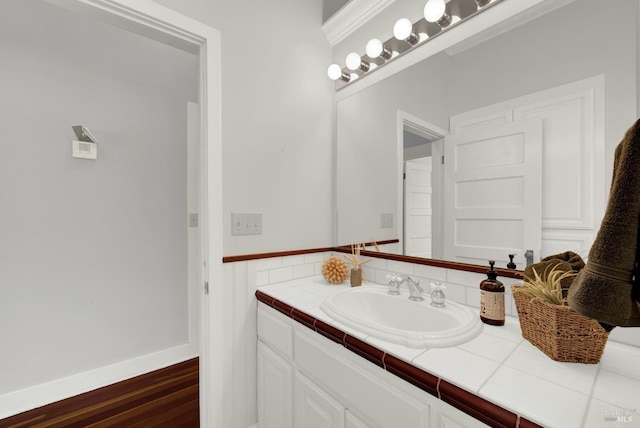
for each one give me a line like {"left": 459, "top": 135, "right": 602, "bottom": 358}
{"left": 443, "top": 120, "right": 542, "bottom": 267}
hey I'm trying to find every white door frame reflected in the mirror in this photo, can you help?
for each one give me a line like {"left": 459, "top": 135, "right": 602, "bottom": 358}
{"left": 396, "top": 110, "right": 449, "bottom": 259}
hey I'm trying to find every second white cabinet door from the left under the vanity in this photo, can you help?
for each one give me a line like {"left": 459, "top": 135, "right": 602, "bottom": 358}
{"left": 294, "top": 372, "right": 345, "bottom": 428}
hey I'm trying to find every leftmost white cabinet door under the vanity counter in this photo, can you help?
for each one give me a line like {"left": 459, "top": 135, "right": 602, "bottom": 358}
{"left": 258, "top": 342, "right": 293, "bottom": 428}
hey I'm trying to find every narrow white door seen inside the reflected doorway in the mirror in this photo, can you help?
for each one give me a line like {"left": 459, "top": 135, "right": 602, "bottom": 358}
{"left": 404, "top": 156, "right": 433, "bottom": 258}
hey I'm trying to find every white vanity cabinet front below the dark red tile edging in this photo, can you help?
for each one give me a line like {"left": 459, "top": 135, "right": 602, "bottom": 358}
{"left": 258, "top": 303, "right": 485, "bottom": 428}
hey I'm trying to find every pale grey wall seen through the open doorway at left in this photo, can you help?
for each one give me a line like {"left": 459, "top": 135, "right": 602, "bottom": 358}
{"left": 0, "top": 0, "right": 198, "bottom": 398}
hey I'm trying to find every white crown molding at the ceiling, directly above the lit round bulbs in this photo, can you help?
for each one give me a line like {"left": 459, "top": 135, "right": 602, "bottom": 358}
{"left": 322, "top": 0, "right": 396, "bottom": 47}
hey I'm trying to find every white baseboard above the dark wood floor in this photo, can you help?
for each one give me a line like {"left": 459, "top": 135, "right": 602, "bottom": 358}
{"left": 0, "top": 344, "right": 198, "bottom": 419}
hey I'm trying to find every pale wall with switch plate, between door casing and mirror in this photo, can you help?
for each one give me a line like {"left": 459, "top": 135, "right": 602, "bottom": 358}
{"left": 151, "top": 0, "right": 334, "bottom": 255}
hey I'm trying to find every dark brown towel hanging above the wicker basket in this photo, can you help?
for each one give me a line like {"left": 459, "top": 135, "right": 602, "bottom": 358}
{"left": 568, "top": 120, "right": 640, "bottom": 328}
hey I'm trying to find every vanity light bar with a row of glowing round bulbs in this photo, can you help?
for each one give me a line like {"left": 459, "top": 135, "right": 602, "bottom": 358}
{"left": 327, "top": 0, "right": 503, "bottom": 89}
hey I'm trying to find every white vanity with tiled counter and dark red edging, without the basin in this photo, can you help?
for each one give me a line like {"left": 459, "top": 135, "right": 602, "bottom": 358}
{"left": 256, "top": 276, "right": 640, "bottom": 428}
